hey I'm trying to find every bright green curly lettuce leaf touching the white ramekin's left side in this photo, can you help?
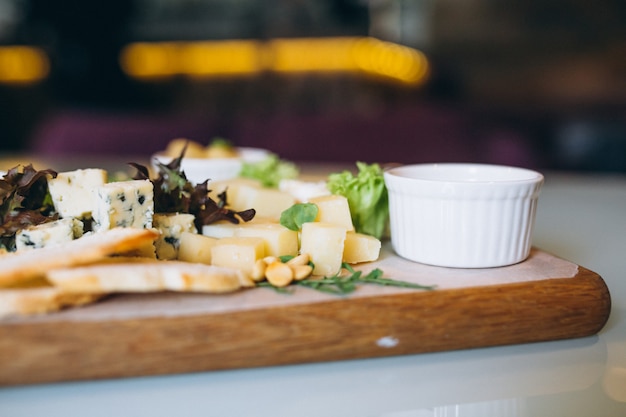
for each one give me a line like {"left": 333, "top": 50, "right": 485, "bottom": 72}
{"left": 327, "top": 162, "right": 389, "bottom": 239}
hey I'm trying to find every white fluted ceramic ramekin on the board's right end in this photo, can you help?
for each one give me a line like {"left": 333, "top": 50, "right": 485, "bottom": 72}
{"left": 384, "top": 163, "right": 544, "bottom": 268}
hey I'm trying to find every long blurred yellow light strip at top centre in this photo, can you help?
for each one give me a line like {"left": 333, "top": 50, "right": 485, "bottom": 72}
{"left": 120, "top": 37, "right": 429, "bottom": 84}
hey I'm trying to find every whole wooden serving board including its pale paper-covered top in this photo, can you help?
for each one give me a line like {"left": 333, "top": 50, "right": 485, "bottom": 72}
{"left": 0, "top": 246, "right": 611, "bottom": 386}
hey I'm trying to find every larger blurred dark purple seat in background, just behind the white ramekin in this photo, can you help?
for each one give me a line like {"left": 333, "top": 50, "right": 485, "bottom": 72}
{"left": 234, "top": 103, "right": 478, "bottom": 163}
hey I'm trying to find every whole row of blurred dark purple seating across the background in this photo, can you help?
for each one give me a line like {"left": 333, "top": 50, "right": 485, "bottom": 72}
{"left": 31, "top": 105, "right": 533, "bottom": 166}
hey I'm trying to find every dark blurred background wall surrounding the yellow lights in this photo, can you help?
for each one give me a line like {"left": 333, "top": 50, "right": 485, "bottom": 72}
{"left": 0, "top": 0, "right": 626, "bottom": 170}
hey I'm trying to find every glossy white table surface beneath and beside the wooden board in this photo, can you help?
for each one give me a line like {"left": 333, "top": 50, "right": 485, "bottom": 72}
{"left": 0, "top": 166, "right": 626, "bottom": 417}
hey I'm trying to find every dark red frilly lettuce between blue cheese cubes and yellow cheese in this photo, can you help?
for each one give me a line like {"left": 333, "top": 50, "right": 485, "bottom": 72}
{"left": 129, "top": 145, "right": 256, "bottom": 230}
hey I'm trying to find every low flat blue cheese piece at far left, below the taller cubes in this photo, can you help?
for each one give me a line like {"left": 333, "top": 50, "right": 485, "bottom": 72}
{"left": 15, "top": 218, "right": 83, "bottom": 250}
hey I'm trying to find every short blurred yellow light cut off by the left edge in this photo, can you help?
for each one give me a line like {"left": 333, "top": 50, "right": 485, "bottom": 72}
{"left": 0, "top": 46, "right": 50, "bottom": 84}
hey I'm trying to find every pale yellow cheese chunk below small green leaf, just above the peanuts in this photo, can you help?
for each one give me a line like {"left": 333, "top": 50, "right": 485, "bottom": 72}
{"left": 236, "top": 222, "right": 298, "bottom": 256}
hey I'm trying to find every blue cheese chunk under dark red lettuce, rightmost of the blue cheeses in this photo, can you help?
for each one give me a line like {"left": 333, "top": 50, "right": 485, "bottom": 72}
{"left": 152, "top": 213, "right": 197, "bottom": 259}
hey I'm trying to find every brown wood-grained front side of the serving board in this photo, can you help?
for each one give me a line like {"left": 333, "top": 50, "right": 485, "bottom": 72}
{"left": 0, "top": 267, "right": 611, "bottom": 386}
